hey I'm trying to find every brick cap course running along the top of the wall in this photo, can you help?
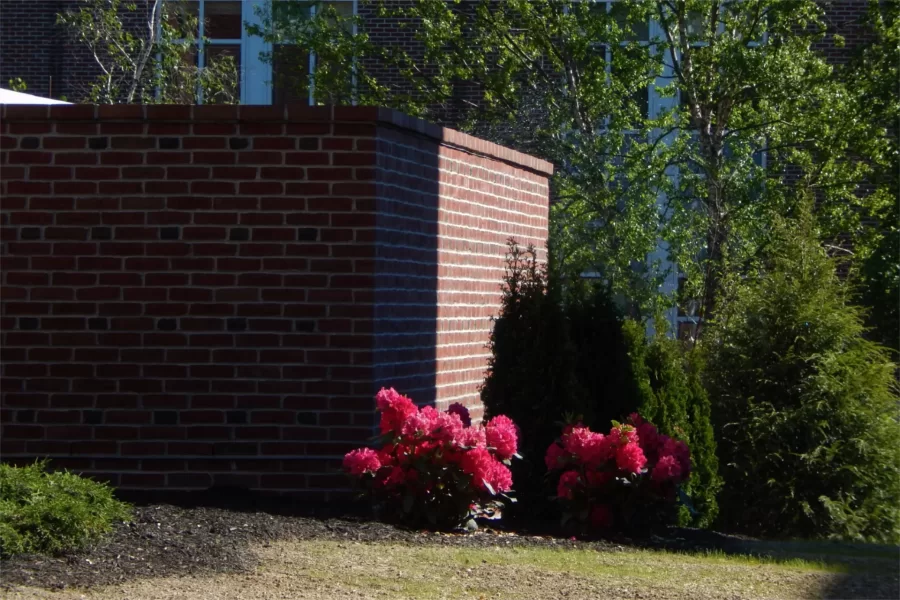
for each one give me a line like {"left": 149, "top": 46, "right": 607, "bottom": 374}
{"left": 2, "top": 104, "right": 553, "bottom": 177}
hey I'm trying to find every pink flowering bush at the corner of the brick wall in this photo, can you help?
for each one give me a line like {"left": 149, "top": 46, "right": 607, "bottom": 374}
{"left": 344, "top": 388, "right": 518, "bottom": 527}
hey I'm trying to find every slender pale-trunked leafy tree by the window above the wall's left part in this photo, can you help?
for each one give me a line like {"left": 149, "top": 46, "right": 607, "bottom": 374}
{"left": 57, "top": 0, "right": 238, "bottom": 104}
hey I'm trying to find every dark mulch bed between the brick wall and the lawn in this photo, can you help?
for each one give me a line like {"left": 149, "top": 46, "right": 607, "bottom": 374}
{"left": 0, "top": 504, "right": 897, "bottom": 598}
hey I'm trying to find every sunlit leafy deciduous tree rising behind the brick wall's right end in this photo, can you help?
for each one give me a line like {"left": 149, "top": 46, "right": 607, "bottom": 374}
{"left": 255, "top": 0, "right": 886, "bottom": 328}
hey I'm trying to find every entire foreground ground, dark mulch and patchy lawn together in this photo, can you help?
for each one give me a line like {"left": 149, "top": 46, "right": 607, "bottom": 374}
{"left": 0, "top": 505, "right": 900, "bottom": 600}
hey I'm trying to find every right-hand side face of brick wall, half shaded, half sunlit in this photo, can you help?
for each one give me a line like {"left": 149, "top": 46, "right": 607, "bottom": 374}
{"left": 376, "top": 115, "right": 549, "bottom": 418}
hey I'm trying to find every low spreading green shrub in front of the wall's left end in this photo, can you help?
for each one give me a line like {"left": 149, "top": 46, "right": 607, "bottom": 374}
{"left": 0, "top": 461, "right": 131, "bottom": 558}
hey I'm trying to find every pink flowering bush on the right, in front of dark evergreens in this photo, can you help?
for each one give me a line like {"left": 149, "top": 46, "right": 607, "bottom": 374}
{"left": 544, "top": 413, "right": 691, "bottom": 531}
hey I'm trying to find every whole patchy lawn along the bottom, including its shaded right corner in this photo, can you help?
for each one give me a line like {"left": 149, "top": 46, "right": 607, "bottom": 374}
{"left": 9, "top": 537, "right": 898, "bottom": 600}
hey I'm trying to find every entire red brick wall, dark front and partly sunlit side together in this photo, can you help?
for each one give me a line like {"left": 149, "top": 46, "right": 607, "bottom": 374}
{"left": 0, "top": 105, "right": 550, "bottom": 499}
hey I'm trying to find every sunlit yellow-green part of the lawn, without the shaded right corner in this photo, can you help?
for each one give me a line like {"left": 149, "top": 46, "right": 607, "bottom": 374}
{"left": 268, "top": 543, "right": 896, "bottom": 598}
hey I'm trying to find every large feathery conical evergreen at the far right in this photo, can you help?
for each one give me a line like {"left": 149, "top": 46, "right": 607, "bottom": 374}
{"left": 704, "top": 205, "right": 900, "bottom": 543}
